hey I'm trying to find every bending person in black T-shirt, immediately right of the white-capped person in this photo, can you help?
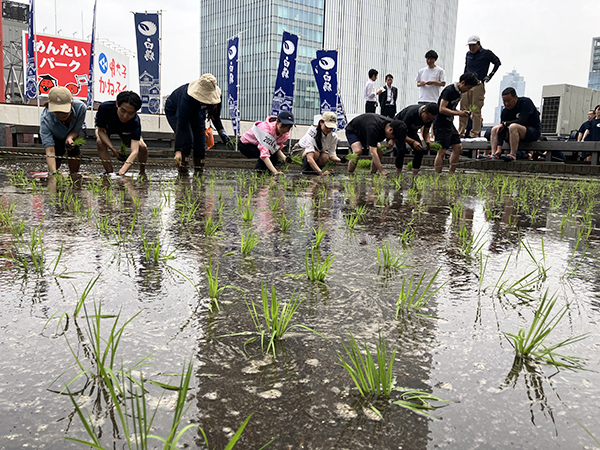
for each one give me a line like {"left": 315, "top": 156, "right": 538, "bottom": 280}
{"left": 346, "top": 113, "right": 406, "bottom": 175}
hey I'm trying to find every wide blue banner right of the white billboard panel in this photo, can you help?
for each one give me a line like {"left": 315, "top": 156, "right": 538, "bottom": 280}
{"left": 133, "top": 13, "right": 160, "bottom": 114}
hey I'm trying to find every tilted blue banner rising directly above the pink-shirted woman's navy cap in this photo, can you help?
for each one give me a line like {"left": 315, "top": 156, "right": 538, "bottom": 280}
{"left": 271, "top": 31, "right": 298, "bottom": 116}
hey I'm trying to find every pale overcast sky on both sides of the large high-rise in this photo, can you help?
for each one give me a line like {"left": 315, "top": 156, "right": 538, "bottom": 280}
{"left": 30, "top": 0, "right": 600, "bottom": 122}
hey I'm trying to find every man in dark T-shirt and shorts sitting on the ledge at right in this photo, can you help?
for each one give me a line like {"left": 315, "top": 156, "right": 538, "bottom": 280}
{"left": 490, "top": 87, "right": 542, "bottom": 162}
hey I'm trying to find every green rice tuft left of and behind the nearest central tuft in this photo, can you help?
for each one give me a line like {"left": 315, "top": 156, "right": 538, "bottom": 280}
{"left": 244, "top": 281, "right": 324, "bottom": 357}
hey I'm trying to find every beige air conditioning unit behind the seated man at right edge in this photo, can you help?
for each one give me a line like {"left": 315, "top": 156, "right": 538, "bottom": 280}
{"left": 541, "top": 84, "right": 600, "bottom": 136}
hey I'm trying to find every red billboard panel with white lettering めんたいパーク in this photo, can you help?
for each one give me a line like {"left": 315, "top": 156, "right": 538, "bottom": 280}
{"left": 23, "top": 33, "right": 91, "bottom": 98}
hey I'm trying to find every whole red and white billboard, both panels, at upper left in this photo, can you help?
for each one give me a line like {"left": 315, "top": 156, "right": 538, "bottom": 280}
{"left": 23, "top": 32, "right": 129, "bottom": 102}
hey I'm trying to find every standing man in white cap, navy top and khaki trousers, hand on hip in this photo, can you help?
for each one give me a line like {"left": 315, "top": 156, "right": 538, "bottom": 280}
{"left": 458, "top": 35, "right": 502, "bottom": 138}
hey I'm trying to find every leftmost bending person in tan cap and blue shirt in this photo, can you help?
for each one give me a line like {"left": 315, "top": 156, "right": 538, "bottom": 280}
{"left": 40, "top": 86, "right": 86, "bottom": 175}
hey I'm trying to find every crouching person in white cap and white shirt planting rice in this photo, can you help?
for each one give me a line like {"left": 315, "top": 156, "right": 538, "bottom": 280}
{"left": 292, "top": 111, "right": 340, "bottom": 175}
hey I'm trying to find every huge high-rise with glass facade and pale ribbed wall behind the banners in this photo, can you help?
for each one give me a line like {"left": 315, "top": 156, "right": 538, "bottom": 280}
{"left": 200, "top": 0, "right": 458, "bottom": 124}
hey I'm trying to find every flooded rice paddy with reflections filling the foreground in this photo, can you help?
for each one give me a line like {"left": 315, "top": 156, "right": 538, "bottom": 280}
{"left": 0, "top": 162, "right": 600, "bottom": 449}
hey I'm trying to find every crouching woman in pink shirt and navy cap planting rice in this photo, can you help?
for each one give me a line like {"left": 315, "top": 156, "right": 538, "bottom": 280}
{"left": 238, "top": 111, "right": 294, "bottom": 175}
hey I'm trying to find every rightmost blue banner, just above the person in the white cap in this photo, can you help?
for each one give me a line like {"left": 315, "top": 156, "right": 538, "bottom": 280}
{"left": 310, "top": 50, "right": 347, "bottom": 130}
